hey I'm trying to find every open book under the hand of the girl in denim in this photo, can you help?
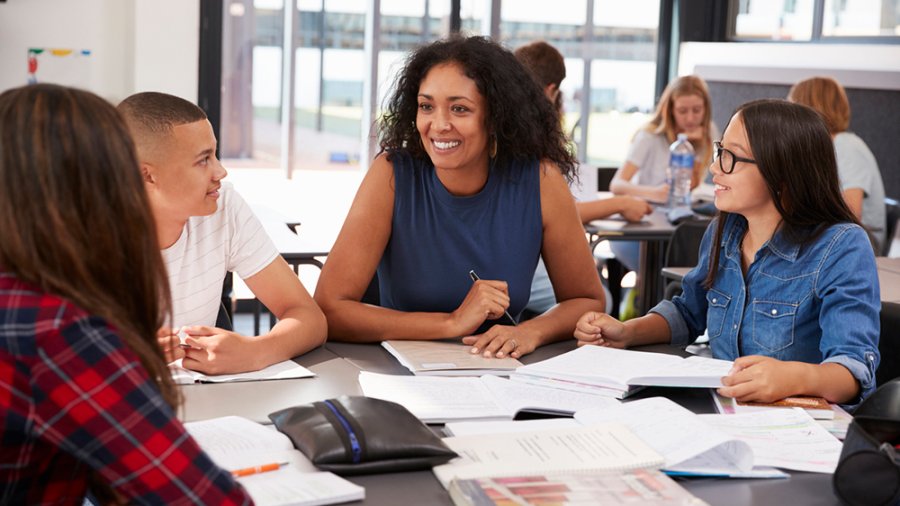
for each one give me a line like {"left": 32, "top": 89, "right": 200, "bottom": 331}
{"left": 510, "top": 346, "right": 732, "bottom": 399}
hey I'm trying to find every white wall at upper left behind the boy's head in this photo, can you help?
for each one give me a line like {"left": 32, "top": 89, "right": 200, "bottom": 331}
{"left": 0, "top": 0, "right": 200, "bottom": 103}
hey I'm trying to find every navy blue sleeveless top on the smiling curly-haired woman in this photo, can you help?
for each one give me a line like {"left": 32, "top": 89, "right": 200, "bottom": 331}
{"left": 377, "top": 151, "right": 543, "bottom": 332}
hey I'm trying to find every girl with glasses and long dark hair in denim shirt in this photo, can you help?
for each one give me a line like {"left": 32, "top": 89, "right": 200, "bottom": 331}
{"left": 575, "top": 100, "right": 881, "bottom": 404}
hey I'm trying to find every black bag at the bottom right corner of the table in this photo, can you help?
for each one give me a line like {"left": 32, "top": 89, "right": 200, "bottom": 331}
{"left": 832, "top": 378, "right": 900, "bottom": 506}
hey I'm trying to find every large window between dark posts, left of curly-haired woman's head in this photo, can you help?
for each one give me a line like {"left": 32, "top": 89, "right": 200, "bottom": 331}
{"left": 220, "top": 0, "right": 442, "bottom": 170}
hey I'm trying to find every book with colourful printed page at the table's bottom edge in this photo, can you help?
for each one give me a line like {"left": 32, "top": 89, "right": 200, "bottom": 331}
{"left": 448, "top": 469, "right": 706, "bottom": 506}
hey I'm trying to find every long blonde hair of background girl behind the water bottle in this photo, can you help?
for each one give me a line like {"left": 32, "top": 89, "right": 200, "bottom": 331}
{"left": 644, "top": 75, "right": 713, "bottom": 187}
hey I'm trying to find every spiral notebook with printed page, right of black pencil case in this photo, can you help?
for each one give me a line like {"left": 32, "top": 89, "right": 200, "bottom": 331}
{"left": 433, "top": 423, "right": 664, "bottom": 488}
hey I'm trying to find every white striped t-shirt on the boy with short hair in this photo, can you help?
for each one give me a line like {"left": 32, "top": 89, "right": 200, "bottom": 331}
{"left": 162, "top": 183, "right": 278, "bottom": 329}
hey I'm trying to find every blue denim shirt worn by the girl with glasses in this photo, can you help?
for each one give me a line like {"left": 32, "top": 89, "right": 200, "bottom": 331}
{"left": 651, "top": 214, "right": 881, "bottom": 404}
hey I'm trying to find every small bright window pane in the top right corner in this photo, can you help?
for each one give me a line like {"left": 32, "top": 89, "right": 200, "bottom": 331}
{"left": 822, "top": 0, "right": 900, "bottom": 37}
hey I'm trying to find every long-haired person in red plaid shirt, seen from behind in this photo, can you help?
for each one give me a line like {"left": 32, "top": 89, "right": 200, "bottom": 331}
{"left": 0, "top": 84, "right": 251, "bottom": 504}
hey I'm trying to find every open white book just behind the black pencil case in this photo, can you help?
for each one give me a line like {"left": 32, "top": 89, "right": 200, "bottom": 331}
{"left": 359, "top": 371, "right": 618, "bottom": 423}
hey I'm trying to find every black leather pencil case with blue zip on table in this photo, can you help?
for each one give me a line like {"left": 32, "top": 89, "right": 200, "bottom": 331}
{"left": 269, "top": 395, "right": 458, "bottom": 475}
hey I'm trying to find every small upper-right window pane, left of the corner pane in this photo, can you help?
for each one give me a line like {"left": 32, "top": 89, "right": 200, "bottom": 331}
{"left": 734, "top": 0, "right": 815, "bottom": 40}
